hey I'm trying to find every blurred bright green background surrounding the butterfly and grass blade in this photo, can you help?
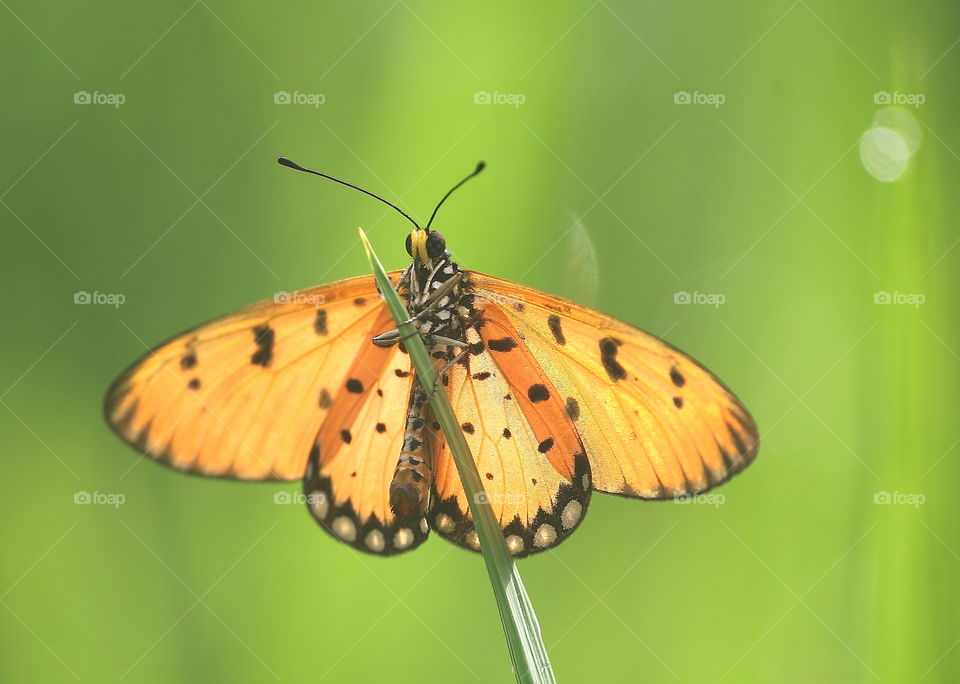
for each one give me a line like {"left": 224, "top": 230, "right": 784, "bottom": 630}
{"left": 0, "top": 0, "right": 960, "bottom": 682}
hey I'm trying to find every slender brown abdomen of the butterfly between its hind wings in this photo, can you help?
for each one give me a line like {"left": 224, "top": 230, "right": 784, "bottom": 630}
{"left": 390, "top": 379, "right": 433, "bottom": 520}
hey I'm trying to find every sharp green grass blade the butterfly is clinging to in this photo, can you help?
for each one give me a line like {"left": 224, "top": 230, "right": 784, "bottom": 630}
{"left": 358, "top": 228, "right": 556, "bottom": 684}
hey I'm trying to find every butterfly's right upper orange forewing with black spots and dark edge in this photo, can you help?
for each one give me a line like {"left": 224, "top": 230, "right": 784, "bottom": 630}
{"left": 468, "top": 273, "right": 759, "bottom": 499}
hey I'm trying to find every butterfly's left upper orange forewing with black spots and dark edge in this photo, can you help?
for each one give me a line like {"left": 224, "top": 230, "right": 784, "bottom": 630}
{"left": 105, "top": 271, "right": 406, "bottom": 480}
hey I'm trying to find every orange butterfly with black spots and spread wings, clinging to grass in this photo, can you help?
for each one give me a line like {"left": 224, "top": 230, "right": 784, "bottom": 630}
{"left": 105, "top": 157, "right": 759, "bottom": 557}
